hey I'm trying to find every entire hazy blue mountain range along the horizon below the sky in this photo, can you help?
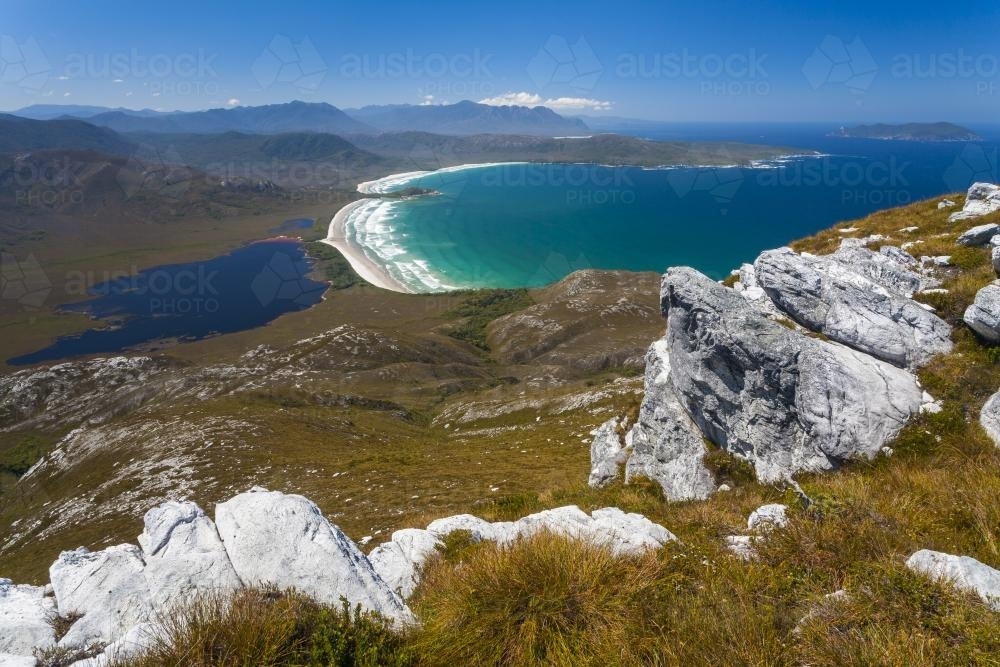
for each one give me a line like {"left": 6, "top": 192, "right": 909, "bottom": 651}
{"left": 14, "top": 101, "right": 589, "bottom": 137}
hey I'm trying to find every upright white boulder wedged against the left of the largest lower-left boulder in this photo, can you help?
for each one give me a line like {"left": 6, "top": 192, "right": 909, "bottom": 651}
{"left": 139, "top": 502, "right": 241, "bottom": 611}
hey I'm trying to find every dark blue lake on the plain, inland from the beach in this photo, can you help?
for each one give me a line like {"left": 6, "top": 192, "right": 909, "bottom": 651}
{"left": 7, "top": 239, "right": 327, "bottom": 366}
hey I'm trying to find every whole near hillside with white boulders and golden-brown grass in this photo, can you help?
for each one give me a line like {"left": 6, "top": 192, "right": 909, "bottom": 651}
{"left": 0, "top": 184, "right": 1000, "bottom": 665}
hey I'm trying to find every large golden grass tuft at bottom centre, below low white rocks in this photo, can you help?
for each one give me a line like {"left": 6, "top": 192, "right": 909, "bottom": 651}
{"left": 414, "top": 533, "right": 661, "bottom": 665}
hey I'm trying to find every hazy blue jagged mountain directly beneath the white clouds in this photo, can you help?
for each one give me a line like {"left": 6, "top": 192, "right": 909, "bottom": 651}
{"left": 347, "top": 101, "right": 589, "bottom": 137}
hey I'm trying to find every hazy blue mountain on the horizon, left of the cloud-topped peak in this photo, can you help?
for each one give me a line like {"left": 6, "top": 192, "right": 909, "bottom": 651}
{"left": 80, "top": 101, "right": 376, "bottom": 134}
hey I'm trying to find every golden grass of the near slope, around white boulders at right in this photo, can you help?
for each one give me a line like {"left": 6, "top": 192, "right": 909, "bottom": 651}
{"left": 402, "top": 192, "right": 1000, "bottom": 665}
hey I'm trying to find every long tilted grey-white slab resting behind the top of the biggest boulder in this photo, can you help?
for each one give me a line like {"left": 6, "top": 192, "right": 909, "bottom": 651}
{"left": 754, "top": 248, "right": 952, "bottom": 367}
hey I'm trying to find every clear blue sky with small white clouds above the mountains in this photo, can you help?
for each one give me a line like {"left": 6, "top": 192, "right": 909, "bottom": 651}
{"left": 0, "top": 0, "right": 1000, "bottom": 122}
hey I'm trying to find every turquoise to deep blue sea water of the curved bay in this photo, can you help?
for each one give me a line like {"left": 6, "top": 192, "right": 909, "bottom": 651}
{"left": 347, "top": 125, "right": 996, "bottom": 291}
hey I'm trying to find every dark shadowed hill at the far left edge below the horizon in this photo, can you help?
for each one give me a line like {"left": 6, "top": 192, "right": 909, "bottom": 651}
{"left": 0, "top": 114, "right": 135, "bottom": 155}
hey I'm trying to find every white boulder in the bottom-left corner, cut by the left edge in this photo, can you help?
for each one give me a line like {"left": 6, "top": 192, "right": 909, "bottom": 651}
{"left": 0, "top": 579, "right": 56, "bottom": 655}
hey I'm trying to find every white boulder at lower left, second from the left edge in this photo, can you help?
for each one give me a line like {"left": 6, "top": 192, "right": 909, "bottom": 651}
{"left": 49, "top": 544, "right": 153, "bottom": 647}
